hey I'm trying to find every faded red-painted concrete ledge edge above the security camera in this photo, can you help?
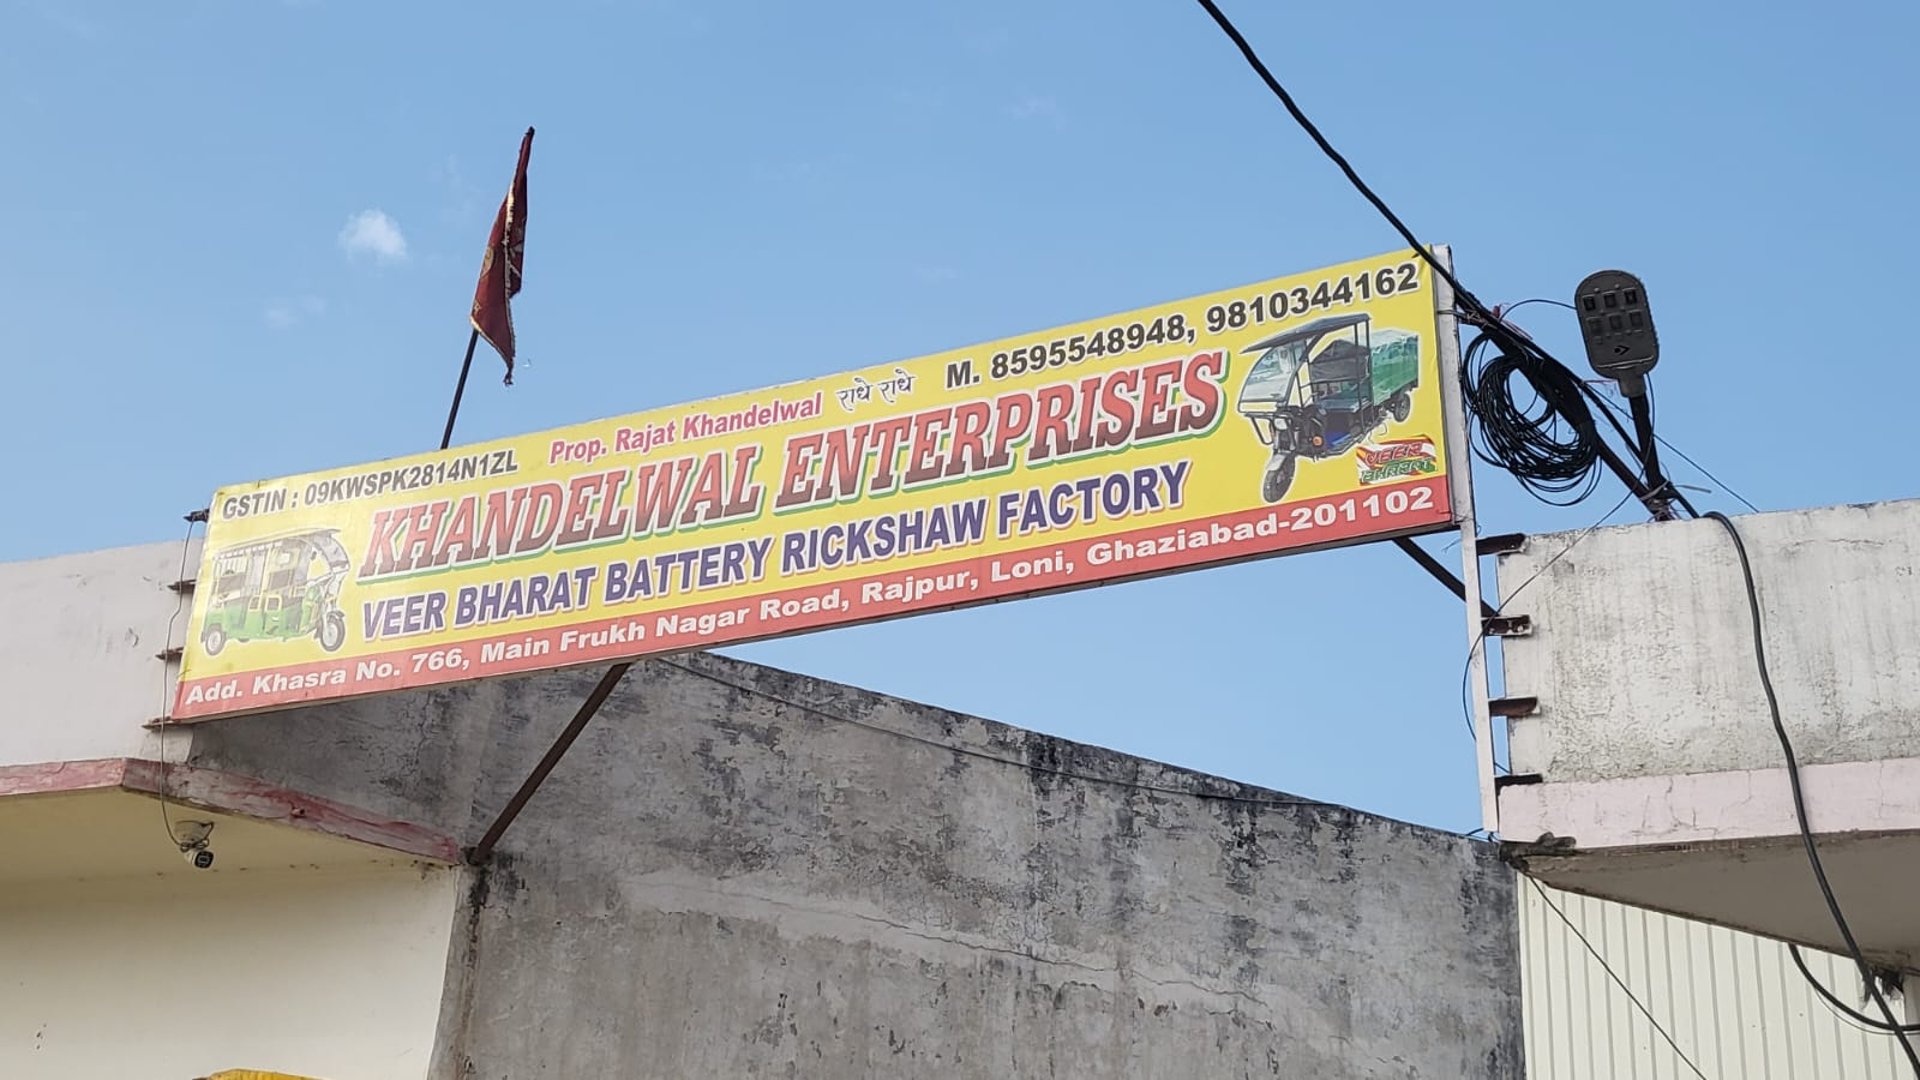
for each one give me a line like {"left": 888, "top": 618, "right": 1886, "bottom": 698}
{"left": 0, "top": 757, "right": 461, "bottom": 865}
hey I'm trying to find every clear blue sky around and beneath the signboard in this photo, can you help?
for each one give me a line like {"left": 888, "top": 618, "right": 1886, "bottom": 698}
{"left": 0, "top": 0, "right": 1920, "bottom": 830}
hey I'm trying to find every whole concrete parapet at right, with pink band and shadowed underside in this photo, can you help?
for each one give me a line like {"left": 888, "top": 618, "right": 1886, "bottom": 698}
{"left": 1500, "top": 502, "right": 1920, "bottom": 967}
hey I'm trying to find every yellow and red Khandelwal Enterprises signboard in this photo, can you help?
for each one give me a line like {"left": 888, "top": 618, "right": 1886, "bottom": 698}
{"left": 173, "top": 252, "right": 1453, "bottom": 721}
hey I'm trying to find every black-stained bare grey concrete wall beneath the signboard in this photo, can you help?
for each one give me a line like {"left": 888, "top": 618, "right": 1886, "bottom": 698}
{"left": 194, "top": 657, "right": 1521, "bottom": 1080}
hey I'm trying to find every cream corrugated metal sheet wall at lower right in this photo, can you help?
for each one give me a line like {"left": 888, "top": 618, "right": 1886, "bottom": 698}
{"left": 1521, "top": 878, "right": 1910, "bottom": 1080}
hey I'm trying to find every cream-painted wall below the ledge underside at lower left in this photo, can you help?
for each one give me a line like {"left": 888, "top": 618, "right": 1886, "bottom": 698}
{"left": 0, "top": 857, "right": 459, "bottom": 1080}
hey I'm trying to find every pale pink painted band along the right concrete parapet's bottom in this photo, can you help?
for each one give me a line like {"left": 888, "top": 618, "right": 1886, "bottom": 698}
{"left": 1500, "top": 757, "right": 1920, "bottom": 851}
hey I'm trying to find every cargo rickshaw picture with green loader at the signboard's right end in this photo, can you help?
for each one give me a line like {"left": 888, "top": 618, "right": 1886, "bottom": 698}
{"left": 1238, "top": 313, "right": 1421, "bottom": 502}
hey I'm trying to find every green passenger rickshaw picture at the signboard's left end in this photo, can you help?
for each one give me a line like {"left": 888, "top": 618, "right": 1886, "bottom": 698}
{"left": 200, "top": 528, "right": 353, "bottom": 655}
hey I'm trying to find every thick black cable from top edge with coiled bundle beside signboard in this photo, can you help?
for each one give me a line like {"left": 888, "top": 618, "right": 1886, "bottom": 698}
{"left": 1196, "top": 0, "right": 1684, "bottom": 517}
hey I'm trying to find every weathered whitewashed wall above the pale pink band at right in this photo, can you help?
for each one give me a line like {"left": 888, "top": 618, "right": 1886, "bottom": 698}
{"left": 1500, "top": 502, "right": 1920, "bottom": 780}
